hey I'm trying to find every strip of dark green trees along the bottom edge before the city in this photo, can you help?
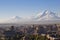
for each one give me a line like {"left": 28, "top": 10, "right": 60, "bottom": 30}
{"left": 0, "top": 34, "right": 48, "bottom": 40}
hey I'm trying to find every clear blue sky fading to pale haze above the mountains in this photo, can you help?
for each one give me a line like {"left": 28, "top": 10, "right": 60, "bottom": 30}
{"left": 0, "top": 0, "right": 60, "bottom": 19}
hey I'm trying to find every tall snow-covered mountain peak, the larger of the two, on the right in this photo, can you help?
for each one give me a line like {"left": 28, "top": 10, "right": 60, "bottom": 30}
{"left": 36, "top": 10, "right": 60, "bottom": 20}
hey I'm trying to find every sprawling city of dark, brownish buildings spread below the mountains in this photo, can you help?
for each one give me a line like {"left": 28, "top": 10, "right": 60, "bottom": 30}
{"left": 0, "top": 24, "right": 60, "bottom": 40}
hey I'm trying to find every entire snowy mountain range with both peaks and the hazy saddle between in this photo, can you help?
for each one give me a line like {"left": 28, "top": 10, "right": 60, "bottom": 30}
{"left": 0, "top": 10, "right": 60, "bottom": 24}
